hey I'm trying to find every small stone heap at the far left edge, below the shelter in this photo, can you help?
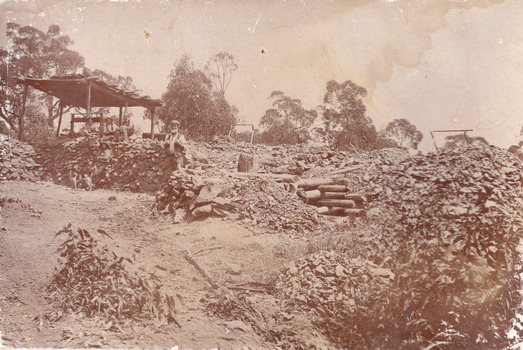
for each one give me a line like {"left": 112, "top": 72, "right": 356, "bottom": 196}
{"left": 0, "top": 135, "right": 41, "bottom": 181}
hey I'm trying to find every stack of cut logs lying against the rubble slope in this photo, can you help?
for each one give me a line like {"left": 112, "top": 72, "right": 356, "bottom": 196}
{"left": 297, "top": 178, "right": 369, "bottom": 216}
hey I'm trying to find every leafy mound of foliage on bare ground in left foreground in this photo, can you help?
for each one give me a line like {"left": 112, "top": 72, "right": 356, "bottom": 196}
{"left": 49, "top": 224, "right": 178, "bottom": 325}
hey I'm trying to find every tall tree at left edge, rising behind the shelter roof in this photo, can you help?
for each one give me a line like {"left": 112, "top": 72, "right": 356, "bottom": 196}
{"left": 0, "top": 23, "right": 84, "bottom": 139}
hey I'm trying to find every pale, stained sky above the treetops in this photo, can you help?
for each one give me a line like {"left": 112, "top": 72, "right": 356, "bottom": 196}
{"left": 0, "top": 0, "right": 523, "bottom": 151}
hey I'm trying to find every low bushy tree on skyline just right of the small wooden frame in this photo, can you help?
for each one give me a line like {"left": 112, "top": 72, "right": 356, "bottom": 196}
{"left": 260, "top": 91, "right": 317, "bottom": 145}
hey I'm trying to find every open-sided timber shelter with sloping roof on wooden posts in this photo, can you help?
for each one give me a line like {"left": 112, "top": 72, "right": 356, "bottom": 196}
{"left": 17, "top": 75, "right": 162, "bottom": 139}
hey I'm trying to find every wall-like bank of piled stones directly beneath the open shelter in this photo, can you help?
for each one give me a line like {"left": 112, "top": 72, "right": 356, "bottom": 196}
{"left": 39, "top": 138, "right": 173, "bottom": 192}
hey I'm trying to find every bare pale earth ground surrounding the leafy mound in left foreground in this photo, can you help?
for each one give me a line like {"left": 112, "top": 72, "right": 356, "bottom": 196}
{"left": 0, "top": 182, "right": 307, "bottom": 349}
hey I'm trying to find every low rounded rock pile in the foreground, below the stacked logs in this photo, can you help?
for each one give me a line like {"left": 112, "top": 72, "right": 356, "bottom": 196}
{"left": 277, "top": 251, "right": 394, "bottom": 319}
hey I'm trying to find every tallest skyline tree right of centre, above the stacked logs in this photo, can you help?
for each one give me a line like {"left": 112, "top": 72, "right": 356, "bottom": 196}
{"left": 321, "top": 80, "right": 378, "bottom": 149}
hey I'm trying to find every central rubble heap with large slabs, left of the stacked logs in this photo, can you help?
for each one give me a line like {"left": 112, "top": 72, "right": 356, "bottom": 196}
{"left": 155, "top": 169, "right": 321, "bottom": 234}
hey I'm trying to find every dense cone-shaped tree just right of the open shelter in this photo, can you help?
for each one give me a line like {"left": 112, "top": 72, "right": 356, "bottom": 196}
{"left": 158, "top": 55, "right": 237, "bottom": 141}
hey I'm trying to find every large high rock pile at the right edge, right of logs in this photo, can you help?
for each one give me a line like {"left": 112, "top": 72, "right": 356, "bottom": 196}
{"left": 360, "top": 145, "right": 523, "bottom": 231}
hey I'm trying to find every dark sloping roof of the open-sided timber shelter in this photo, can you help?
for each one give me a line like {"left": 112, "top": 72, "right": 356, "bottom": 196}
{"left": 18, "top": 75, "right": 162, "bottom": 108}
